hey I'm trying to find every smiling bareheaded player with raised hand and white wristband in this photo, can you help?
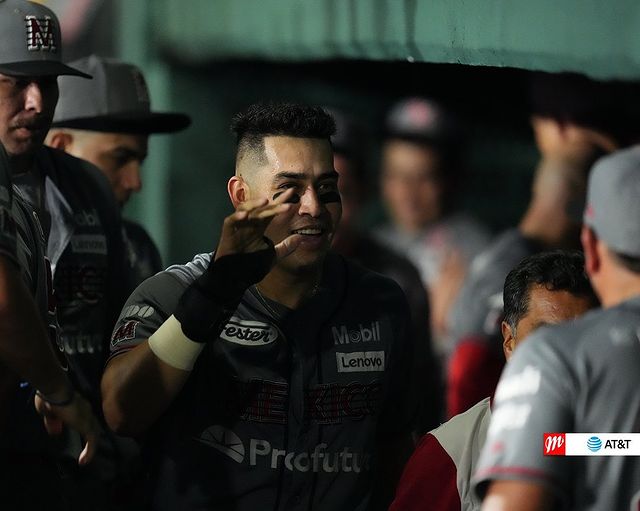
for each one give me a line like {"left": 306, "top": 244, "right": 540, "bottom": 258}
{"left": 102, "top": 104, "right": 414, "bottom": 511}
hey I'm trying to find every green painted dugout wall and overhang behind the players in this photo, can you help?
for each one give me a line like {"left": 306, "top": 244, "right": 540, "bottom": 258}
{"left": 113, "top": 0, "right": 640, "bottom": 262}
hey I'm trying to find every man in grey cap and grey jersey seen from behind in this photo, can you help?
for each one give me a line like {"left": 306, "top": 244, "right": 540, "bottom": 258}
{"left": 474, "top": 147, "right": 640, "bottom": 511}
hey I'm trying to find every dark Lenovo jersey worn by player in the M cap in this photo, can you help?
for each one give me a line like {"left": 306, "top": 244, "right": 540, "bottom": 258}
{"left": 19, "top": 147, "right": 133, "bottom": 403}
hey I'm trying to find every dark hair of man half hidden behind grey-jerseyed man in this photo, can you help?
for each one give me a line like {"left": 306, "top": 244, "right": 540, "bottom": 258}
{"left": 503, "top": 250, "right": 598, "bottom": 335}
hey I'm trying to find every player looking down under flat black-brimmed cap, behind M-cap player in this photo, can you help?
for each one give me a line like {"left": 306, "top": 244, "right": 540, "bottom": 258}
{"left": 46, "top": 55, "right": 191, "bottom": 285}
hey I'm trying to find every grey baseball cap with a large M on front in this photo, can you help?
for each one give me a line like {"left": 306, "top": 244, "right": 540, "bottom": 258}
{"left": 0, "top": 0, "right": 91, "bottom": 78}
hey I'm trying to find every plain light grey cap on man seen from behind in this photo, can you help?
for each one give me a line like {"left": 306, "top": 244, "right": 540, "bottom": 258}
{"left": 584, "top": 146, "right": 640, "bottom": 257}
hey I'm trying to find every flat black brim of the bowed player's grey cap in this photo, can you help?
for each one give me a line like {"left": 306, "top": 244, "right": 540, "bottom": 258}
{"left": 52, "top": 112, "right": 191, "bottom": 135}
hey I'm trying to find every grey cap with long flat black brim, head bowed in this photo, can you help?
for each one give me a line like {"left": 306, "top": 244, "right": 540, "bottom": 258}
{"left": 52, "top": 55, "right": 191, "bottom": 134}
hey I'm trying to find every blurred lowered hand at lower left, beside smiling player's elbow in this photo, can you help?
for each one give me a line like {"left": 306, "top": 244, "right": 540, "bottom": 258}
{"left": 35, "top": 392, "right": 100, "bottom": 465}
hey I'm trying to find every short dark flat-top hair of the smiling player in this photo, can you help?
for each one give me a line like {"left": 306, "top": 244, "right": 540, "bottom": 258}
{"left": 231, "top": 103, "right": 336, "bottom": 160}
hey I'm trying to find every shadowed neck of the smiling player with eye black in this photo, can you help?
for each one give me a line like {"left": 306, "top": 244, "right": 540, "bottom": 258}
{"left": 257, "top": 266, "right": 322, "bottom": 309}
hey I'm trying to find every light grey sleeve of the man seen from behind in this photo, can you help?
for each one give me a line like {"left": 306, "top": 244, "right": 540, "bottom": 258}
{"left": 473, "top": 328, "right": 577, "bottom": 506}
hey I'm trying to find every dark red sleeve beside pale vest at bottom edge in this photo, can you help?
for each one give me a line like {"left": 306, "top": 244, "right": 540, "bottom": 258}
{"left": 389, "top": 433, "right": 461, "bottom": 511}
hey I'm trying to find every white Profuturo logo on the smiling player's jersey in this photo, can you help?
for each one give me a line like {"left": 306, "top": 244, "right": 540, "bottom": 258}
{"left": 197, "top": 425, "right": 371, "bottom": 474}
